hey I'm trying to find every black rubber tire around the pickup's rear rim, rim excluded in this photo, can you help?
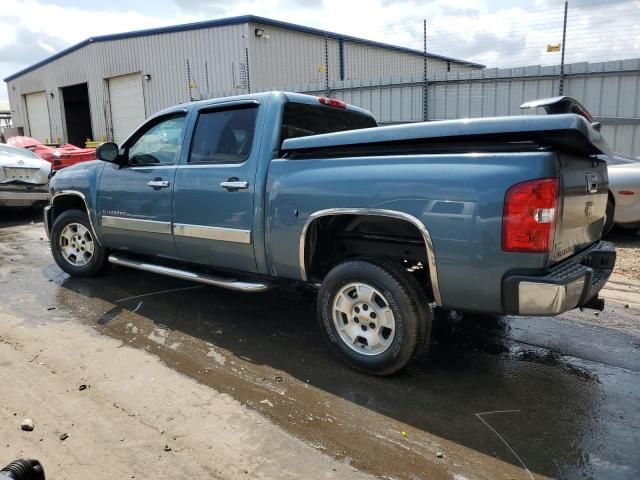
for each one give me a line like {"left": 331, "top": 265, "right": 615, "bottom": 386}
{"left": 317, "top": 259, "right": 431, "bottom": 375}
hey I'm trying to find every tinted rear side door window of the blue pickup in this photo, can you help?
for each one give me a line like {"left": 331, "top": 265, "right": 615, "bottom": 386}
{"left": 189, "top": 106, "right": 258, "bottom": 164}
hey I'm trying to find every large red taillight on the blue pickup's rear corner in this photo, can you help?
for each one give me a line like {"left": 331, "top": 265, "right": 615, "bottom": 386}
{"left": 502, "top": 178, "right": 558, "bottom": 253}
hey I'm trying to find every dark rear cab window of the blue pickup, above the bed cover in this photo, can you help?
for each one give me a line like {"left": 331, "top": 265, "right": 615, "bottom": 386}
{"left": 280, "top": 102, "right": 378, "bottom": 143}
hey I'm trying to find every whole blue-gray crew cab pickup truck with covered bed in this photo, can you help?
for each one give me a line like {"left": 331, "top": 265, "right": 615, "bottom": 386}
{"left": 45, "top": 92, "right": 615, "bottom": 375}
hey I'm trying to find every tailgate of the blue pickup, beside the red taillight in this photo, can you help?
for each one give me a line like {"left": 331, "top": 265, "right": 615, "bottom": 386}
{"left": 551, "top": 154, "right": 609, "bottom": 262}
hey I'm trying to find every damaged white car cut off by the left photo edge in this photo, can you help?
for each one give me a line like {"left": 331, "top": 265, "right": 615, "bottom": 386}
{"left": 0, "top": 144, "right": 51, "bottom": 207}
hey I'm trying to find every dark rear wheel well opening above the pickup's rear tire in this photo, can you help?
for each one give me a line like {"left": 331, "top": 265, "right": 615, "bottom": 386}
{"left": 301, "top": 214, "right": 433, "bottom": 299}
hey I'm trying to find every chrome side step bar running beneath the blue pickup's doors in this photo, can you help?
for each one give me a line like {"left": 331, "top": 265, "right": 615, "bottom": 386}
{"left": 109, "top": 255, "right": 271, "bottom": 292}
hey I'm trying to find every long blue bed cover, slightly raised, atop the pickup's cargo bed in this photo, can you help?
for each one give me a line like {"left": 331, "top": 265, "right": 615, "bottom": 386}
{"left": 282, "top": 114, "right": 611, "bottom": 156}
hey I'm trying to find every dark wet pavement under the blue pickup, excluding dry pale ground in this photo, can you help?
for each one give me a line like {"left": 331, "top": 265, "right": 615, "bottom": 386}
{"left": 0, "top": 211, "right": 640, "bottom": 480}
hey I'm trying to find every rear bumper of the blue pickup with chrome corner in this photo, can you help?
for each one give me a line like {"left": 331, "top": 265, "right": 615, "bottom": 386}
{"left": 503, "top": 241, "right": 616, "bottom": 316}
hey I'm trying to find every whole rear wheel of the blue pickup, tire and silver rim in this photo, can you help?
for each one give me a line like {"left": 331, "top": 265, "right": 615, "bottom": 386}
{"left": 317, "top": 259, "right": 431, "bottom": 375}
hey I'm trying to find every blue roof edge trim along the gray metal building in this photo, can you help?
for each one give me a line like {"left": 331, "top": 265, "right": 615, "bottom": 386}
{"left": 4, "top": 15, "right": 485, "bottom": 82}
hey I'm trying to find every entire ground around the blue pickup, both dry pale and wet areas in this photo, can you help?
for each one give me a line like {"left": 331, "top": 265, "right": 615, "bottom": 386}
{"left": 0, "top": 211, "right": 640, "bottom": 480}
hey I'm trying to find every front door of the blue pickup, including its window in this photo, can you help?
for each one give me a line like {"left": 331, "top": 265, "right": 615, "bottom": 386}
{"left": 98, "top": 113, "right": 185, "bottom": 258}
